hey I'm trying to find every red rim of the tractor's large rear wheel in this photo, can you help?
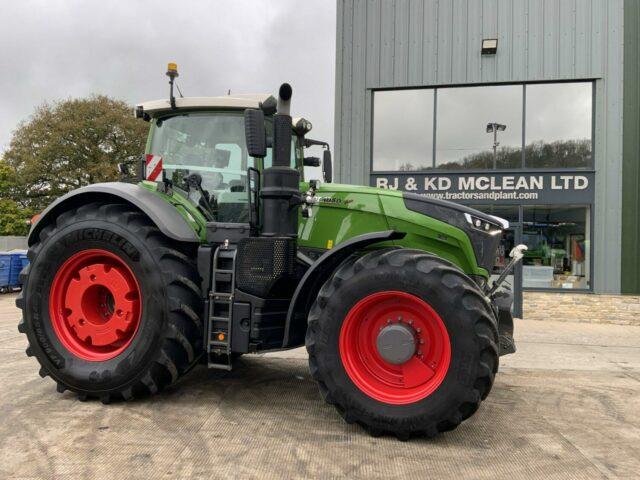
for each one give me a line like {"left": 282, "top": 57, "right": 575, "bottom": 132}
{"left": 49, "top": 249, "right": 142, "bottom": 362}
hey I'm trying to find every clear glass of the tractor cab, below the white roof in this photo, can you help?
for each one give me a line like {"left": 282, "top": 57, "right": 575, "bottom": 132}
{"left": 147, "top": 112, "right": 297, "bottom": 222}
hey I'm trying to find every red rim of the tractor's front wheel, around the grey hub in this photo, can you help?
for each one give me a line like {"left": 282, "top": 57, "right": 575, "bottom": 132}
{"left": 339, "top": 291, "right": 451, "bottom": 405}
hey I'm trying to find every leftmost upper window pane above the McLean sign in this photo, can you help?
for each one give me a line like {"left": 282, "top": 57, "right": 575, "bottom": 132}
{"left": 373, "top": 89, "right": 434, "bottom": 171}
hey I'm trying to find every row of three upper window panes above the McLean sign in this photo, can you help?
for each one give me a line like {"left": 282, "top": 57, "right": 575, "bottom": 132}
{"left": 373, "top": 82, "right": 593, "bottom": 171}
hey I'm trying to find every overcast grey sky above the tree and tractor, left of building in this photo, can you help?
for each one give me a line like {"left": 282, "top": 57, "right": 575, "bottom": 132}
{"left": 0, "top": 0, "right": 336, "bottom": 172}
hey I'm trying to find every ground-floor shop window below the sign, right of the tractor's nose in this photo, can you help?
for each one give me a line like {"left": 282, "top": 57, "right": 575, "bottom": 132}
{"left": 522, "top": 206, "right": 590, "bottom": 289}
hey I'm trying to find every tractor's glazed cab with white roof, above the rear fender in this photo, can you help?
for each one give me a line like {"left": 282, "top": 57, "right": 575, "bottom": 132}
{"left": 136, "top": 94, "right": 331, "bottom": 222}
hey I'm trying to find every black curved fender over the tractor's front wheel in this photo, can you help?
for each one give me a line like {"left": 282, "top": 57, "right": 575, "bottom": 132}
{"left": 282, "top": 230, "right": 406, "bottom": 348}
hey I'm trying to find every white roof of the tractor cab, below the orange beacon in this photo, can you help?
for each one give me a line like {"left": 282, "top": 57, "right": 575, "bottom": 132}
{"left": 136, "top": 93, "right": 270, "bottom": 117}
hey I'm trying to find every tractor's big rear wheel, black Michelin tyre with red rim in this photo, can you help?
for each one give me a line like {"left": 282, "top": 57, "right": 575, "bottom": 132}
{"left": 16, "top": 203, "right": 202, "bottom": 403}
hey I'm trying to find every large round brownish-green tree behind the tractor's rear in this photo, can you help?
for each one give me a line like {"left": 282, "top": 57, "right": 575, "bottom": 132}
{"left": 0, "top": 95, "right": 148, "bottom": 211}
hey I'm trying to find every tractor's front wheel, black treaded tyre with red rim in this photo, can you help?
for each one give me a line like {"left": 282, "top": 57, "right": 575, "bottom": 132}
{"left": 306, "top": 249, "right": 498, "bottom": 440}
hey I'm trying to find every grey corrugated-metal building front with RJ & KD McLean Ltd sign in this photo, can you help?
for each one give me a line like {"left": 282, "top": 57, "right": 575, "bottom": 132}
{"left": 335, "top": 0, "right": 640, "bottom": 295}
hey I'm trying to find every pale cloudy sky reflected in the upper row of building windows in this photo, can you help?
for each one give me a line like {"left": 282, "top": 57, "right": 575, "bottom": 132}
{"left": 373, "top": 82, "right": 592, "bottom": 170}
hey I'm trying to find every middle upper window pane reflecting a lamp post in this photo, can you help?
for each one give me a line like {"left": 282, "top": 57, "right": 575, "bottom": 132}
{"left": 436, "top": 85, "right": 523, "bottom": 170}
